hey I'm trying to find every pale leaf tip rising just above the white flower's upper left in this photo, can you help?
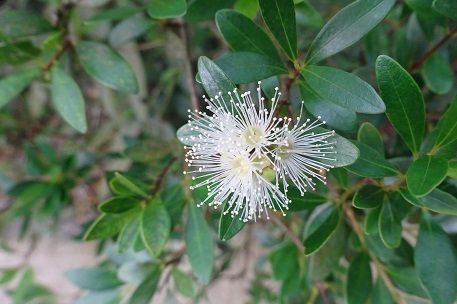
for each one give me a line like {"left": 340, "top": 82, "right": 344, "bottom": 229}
{"left": 198, "top": 56, "right": 235, "bottom": 100}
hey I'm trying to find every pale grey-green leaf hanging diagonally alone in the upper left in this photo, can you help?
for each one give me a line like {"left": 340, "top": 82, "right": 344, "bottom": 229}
{"left": 51, "top": 66, "right": 87, "bottom": 133}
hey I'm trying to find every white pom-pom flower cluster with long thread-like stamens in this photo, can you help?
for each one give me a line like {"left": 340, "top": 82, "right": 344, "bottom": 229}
{"left": 180, "top": 81, "right": 336, "bottom": 221}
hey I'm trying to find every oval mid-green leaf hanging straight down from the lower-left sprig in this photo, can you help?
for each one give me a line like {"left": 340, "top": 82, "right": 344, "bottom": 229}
{"left": 140, "top": 198, "right": 171, "bottom": 256}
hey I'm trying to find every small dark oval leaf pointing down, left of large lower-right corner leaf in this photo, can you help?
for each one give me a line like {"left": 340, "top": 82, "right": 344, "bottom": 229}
{"left": 378, "top": 195, "right": 402, "bottom": 248}
